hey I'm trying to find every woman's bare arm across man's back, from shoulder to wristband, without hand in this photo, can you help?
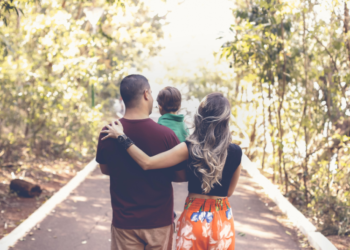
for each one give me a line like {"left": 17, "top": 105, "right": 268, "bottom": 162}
{"left": 127, "top": 142, "right": 188, "bottom": 170}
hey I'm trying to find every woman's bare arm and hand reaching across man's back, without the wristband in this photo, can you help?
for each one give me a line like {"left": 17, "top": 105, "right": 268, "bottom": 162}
{"left": 101, "top": 120, "right": 188, "bottom": 170}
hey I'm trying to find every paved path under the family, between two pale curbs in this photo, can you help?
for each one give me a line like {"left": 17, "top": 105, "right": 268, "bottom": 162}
{"left": 13, "top": 166, "right": 299, "bottom": 250}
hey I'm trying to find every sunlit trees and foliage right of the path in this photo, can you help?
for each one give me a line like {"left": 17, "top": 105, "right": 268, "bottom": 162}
{"left": 222, "top": 0, "right": 350, "bottom": 235}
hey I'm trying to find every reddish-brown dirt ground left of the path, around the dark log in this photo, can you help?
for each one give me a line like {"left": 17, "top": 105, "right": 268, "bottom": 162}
{"left": 0, "top": 157, "right": 91, "bottom": 240}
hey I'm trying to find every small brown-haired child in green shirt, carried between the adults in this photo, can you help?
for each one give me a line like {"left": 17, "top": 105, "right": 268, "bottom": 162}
{"left": 157, "top": 87, "right": 189, "bottom": 142}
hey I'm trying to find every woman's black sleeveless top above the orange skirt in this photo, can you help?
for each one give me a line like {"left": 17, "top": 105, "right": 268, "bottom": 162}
{"left": 185, "top": 141, "right": 242, "bottom": 197}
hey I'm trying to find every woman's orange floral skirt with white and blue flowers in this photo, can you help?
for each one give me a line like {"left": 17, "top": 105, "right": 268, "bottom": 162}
{"left": 176, "top": 197, "right": 235, "bottom": 250}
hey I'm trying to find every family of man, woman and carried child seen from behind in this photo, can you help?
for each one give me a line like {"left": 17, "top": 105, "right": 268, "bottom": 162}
{"left": 96, "top": 75, "right": 242, "bottom": 250}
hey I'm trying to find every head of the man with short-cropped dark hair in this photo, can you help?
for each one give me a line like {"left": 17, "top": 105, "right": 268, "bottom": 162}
{"left": 120, "top": 75, "right": 150, "bottom": 108}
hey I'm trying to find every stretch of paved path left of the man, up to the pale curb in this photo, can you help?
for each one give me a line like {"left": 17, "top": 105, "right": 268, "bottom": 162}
{"left": 14, "top": 168, "right": 112, "bottom": 250}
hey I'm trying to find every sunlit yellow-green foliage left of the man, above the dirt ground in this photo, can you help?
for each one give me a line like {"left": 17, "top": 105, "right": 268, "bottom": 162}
{"left": 0, "top": 0, "right": 163, "bottom": 164}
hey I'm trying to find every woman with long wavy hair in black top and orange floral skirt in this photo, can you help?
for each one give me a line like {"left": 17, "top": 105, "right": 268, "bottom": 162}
{"left": 101, "top": 93, "right": 242, "bottom": 250}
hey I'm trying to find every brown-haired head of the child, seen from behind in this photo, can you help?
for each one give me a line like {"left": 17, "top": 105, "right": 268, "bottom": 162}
{"left": 157, "top": 87, "right": 181, "bottom": 113}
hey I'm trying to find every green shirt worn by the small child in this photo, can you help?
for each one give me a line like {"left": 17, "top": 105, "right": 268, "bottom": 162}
{"left": 158, "top": 113, "right": 189, "bottom": 142}
